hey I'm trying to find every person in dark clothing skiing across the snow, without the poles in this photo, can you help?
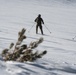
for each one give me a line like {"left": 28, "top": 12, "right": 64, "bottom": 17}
{"left": 35, "top": 14, "right": 44, "bottom": 35}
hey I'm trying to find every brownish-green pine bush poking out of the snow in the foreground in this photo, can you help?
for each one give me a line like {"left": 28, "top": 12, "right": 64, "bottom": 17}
{"left": 2, "top": 28, "right": 47, "bottom": 62}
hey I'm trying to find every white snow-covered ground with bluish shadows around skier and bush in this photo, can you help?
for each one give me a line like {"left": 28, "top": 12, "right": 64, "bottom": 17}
{"left": 0, "top": 0, "right": 76, "bottom": 75}
